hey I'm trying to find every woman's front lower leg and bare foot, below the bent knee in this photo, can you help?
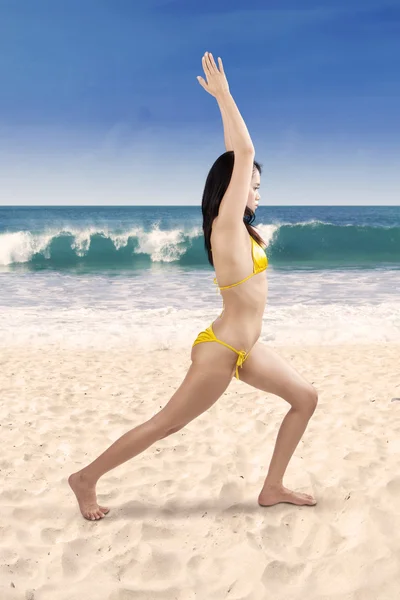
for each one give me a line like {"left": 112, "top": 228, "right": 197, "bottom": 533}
{"left": 259, "top": 407, "right": 315, "bottom": 506}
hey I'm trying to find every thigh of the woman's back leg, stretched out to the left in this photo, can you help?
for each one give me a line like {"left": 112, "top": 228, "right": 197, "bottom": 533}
{"left": 154, "top": 363, "right": 232, "bottom": 430}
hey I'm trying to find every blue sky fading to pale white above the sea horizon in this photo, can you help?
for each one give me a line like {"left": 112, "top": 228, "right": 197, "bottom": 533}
{"left": 0, "top": 0, "right": 400, "bottom": 205}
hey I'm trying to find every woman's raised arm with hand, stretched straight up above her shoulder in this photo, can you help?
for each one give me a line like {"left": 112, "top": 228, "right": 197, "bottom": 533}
{"left": 197, "top": 52, "right": 254, "bottom": 225}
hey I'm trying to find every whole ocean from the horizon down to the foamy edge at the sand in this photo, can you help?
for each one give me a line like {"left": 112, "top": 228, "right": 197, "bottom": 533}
{"left": 0, "top": 206, "right": 400, "bottom": 351}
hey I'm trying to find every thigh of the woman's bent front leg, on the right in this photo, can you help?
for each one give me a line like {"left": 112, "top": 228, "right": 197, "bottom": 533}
{"left": 240, "top": 342, "right": 315, "bottom": 405}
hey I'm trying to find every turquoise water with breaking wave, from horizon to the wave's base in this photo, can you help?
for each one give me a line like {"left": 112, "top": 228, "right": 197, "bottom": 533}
{"left": 0, "top": 206, "right": 400, "bottom": 272}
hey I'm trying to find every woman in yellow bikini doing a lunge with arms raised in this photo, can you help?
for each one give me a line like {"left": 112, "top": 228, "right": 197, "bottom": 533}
{"left": 69, "top": 52, "right": 317, "bottom": 520}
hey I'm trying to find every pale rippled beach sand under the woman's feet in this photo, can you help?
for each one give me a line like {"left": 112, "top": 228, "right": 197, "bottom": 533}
{"left": 0, "top": 344, "right": 400, "bottom": 600}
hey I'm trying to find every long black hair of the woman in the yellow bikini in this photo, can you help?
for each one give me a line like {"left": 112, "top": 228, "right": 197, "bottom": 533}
{"left": 201, "top": 150, "right": 266, "bottom": 266}
